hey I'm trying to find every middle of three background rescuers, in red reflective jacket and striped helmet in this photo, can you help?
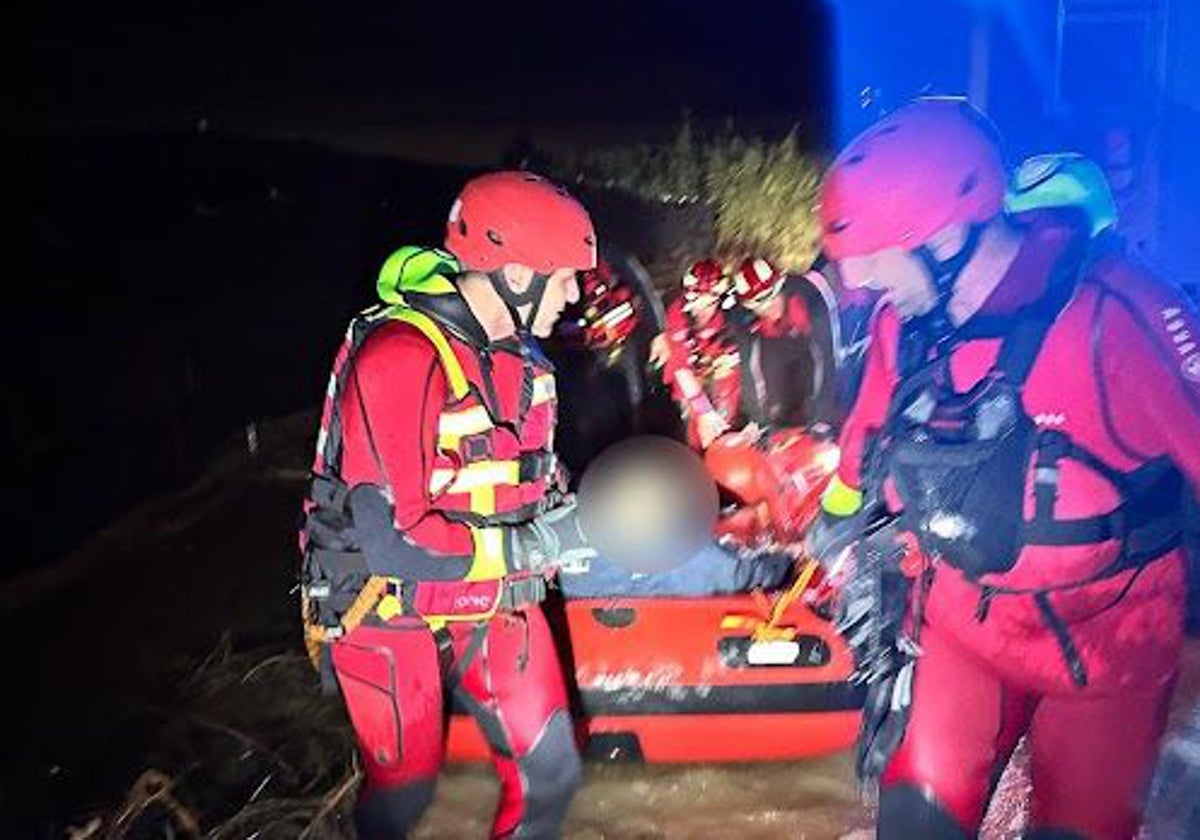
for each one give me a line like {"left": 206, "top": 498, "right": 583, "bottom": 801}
{"left": 650, "top": 259, "right": 740, "bottom": 450}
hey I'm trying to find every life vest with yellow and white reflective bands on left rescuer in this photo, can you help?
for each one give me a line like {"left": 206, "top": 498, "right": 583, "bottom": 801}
{"left": 301, "top": 294, "right": 557, "bottom": 664}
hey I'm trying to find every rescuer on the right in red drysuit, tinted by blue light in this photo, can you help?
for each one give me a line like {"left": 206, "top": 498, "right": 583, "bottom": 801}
{"left": 812, "top": 100, "right": 1200, "bottom": 840}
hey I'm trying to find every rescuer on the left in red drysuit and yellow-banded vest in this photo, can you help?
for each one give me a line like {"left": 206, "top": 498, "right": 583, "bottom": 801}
{"left": 302, "top": 173, "right": 596, "bottom": 839}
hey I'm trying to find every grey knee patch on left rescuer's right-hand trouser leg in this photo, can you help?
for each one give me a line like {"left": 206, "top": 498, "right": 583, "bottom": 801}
{"left": 516, "top": 710, "right": 583, "bottom": 838}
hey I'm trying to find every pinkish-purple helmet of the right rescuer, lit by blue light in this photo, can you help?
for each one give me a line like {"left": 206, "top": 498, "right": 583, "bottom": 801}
{"left": 821, "top": 98, "right": 1007, "bottom": 260}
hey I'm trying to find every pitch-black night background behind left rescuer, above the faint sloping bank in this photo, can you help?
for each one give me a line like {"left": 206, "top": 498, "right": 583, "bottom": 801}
{"left": 7, "top": 1, "right": 828, "bottom": 575}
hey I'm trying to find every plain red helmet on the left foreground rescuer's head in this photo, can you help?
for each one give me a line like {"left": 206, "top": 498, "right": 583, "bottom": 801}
{"left": 445, "top": 172, "right": 596, "bottom": 275}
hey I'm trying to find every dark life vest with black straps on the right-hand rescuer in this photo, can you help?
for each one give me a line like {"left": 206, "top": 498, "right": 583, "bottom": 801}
{"left": 869, "top": 263, "right": 1182, "bottom": 686}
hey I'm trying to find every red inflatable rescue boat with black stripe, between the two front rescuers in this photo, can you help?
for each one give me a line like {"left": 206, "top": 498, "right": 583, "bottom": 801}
{"left": 448, "top": 583, "right": 862, "bottom": 762}
